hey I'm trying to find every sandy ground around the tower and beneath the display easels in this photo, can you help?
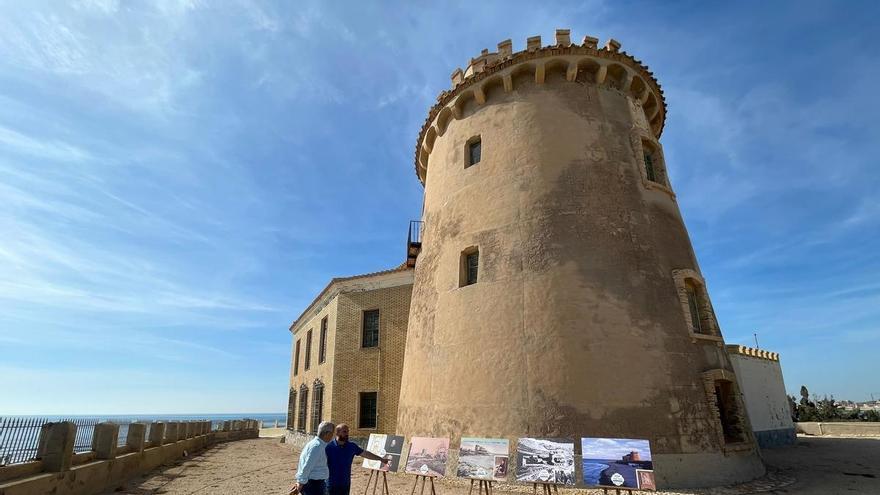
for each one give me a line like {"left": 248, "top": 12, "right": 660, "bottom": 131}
{"left": 108, "top": 437, "right": 880, "bottom": 495}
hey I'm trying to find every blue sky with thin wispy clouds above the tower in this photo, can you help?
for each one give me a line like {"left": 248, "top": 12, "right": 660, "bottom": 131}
{"left": 0, "top": 0, "right": 880, "bottom": 414}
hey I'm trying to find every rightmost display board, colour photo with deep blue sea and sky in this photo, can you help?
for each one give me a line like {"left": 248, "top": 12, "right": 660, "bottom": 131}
{"left": 581, "top": 438, "right": 657, "bottom": 490}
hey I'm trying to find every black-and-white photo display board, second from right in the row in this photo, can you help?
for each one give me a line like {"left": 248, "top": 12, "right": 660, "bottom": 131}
{"left": 516, "top": 438, "right": 575, "bottom": 485}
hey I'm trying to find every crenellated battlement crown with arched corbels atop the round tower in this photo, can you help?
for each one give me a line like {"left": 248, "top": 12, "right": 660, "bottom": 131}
{"left": 415, "top": 29, "right": 666, "bottom": 184}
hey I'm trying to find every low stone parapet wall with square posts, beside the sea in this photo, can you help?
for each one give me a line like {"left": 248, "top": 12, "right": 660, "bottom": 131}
{"left": 0, "top": 420, "right": 259, "bottom": 495}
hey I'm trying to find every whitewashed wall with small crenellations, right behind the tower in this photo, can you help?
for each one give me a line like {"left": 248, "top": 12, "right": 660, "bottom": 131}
{"left": 727, "top": 345, "right": 797, "bottom": 448}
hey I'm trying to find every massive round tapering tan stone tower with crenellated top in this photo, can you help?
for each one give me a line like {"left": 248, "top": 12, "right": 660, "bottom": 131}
{"left": 398, "top": 30, "right": 764, "bottom": 486}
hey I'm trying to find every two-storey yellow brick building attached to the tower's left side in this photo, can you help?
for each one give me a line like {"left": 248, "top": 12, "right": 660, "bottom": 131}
{"left": 287, "top": 264, "right": 413, "bottom": 437}
